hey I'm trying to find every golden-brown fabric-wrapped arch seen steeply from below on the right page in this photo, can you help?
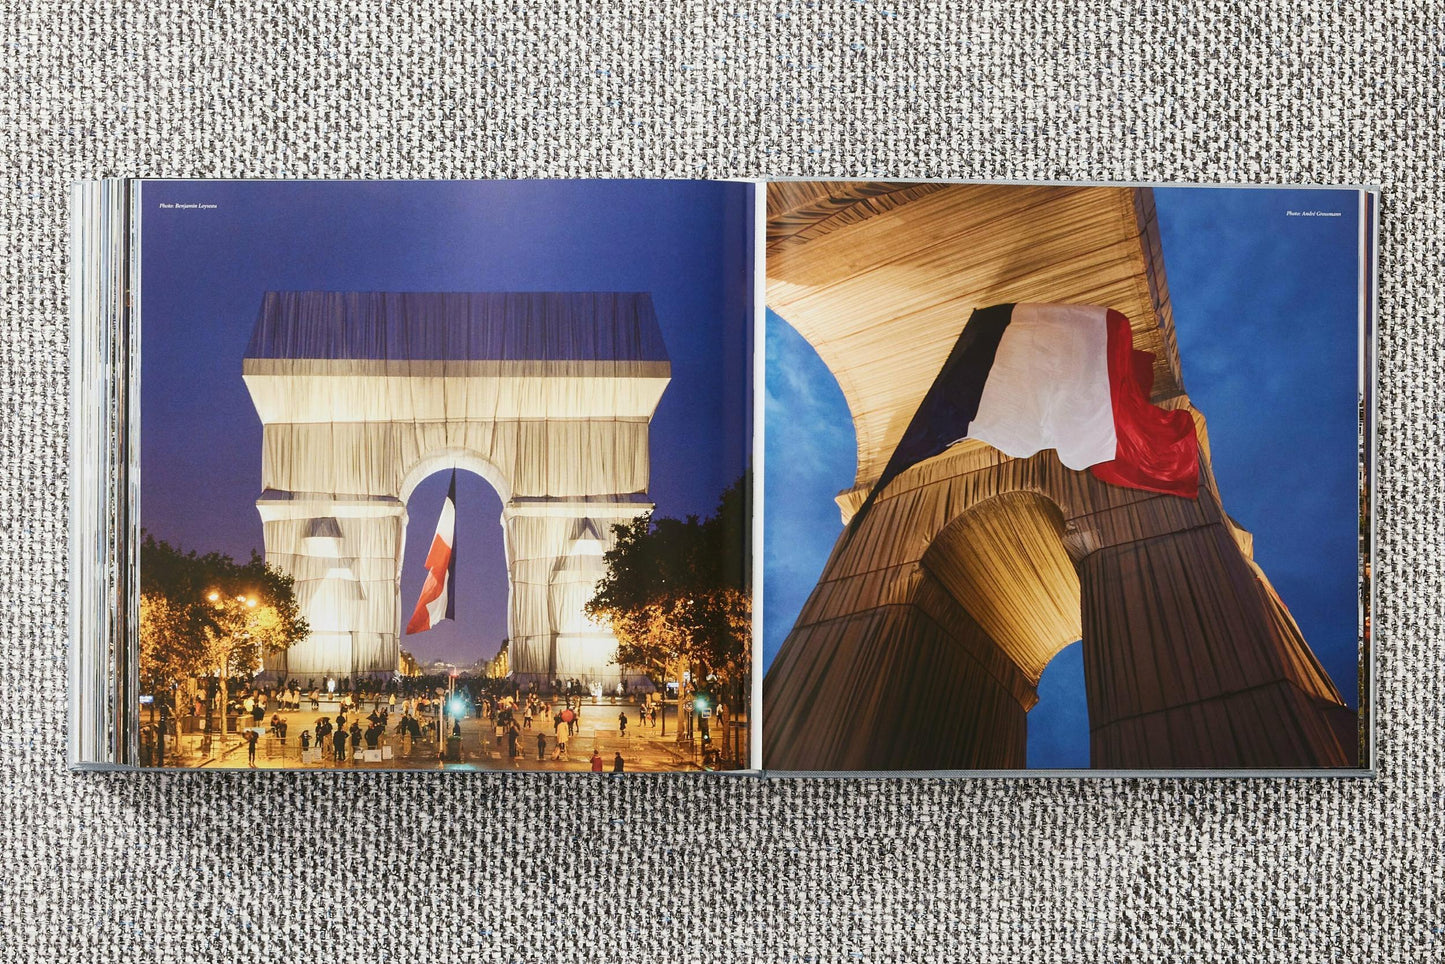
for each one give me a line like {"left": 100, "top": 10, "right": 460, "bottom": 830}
{"left": 763, "top": 182, "right": 1360, "bottom": 770}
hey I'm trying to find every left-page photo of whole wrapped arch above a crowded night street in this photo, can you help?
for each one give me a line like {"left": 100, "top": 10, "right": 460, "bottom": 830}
{"left": 111, "top": 181, "right": 756, "bottom": 773}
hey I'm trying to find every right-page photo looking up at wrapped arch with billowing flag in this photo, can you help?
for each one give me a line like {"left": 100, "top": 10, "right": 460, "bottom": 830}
{"left": 762, "top": 181, "right": 1377, "bottom": 775}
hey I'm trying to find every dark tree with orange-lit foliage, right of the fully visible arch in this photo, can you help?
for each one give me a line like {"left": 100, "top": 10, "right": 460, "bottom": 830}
{"left": 587, "top": 474, "right": 753, "bottom": 739}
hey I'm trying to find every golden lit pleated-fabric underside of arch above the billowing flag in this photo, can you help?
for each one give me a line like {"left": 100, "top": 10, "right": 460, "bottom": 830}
{"left": 767, "top": 181, "right": 1183, "bottom": 494}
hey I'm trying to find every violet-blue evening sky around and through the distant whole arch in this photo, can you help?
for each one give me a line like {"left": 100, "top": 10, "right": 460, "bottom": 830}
{"left": 140, "top": 181, "right": 753, "bottom": 663}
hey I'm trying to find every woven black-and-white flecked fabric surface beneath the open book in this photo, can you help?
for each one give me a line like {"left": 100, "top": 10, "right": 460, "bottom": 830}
{"left": 0, "top": 0, "right": 1445, "bottom": 964}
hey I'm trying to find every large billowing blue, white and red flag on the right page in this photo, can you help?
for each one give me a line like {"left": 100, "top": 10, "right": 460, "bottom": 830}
{"left": 858, "top": 304, "right": 1199, "bottom": 515}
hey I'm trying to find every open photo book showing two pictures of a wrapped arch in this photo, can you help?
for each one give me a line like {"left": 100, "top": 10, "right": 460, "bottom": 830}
{"left": 69, "top": 179, "right": 1377, "bottom": 775}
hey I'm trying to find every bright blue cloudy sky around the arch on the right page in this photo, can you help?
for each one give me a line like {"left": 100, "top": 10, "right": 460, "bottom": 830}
{"left": 763, "top": 188, "right": 1358, "bottom": 767}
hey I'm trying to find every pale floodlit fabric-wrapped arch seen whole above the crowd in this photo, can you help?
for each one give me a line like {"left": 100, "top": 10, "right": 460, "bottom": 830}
{"left": 243, "top": 292, "right": 670, "bottom": 688}
